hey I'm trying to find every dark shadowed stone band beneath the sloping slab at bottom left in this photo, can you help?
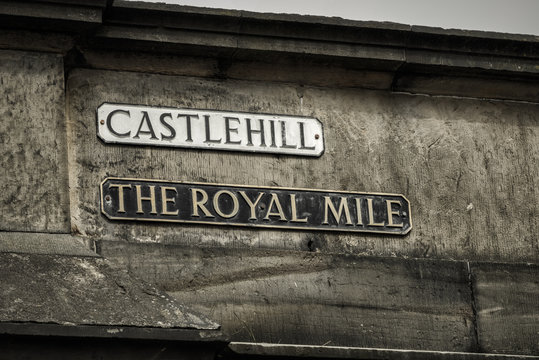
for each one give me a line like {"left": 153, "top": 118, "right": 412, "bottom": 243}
{"left": 0, "top": 323, "right": 228, "bottom": 360}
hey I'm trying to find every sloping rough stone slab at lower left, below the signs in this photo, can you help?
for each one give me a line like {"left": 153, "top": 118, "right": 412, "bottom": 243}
{"left": 0, "top": 253, "right": 219, "bottom": 329}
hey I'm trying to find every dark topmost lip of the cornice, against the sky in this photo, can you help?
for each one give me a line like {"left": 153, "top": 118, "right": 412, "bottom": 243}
{"left": 107, "top": 0, "right": 539, "bottom": 59}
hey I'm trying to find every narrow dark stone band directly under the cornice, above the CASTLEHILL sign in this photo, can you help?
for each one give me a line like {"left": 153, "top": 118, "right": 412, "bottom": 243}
{"left": 78, "top": 49, "right": 539, "bottom": 102}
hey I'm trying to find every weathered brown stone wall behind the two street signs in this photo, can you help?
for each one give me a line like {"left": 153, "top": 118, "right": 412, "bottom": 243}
{"left": 0, "top": 2, "right": 539, "bottom": 355}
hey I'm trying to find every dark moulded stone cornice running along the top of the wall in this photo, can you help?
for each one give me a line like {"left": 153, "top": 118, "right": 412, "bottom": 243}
{"left": 0, "top": 0, "right": 539, "bottom": 102}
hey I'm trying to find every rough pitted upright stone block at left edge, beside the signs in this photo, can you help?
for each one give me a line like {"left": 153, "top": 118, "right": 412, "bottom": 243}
{"left": 0, "top": 51, "right": 69, "bottom": 232}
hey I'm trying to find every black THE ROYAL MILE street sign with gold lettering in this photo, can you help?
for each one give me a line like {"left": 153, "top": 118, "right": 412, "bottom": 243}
{"left": 101, "top": 178, "right": 412, "bottom": 235}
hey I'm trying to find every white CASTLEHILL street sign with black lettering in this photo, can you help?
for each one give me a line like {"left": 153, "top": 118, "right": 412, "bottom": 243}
{"left": 97, "top": 103, "right": 324, "bottom": 157}
